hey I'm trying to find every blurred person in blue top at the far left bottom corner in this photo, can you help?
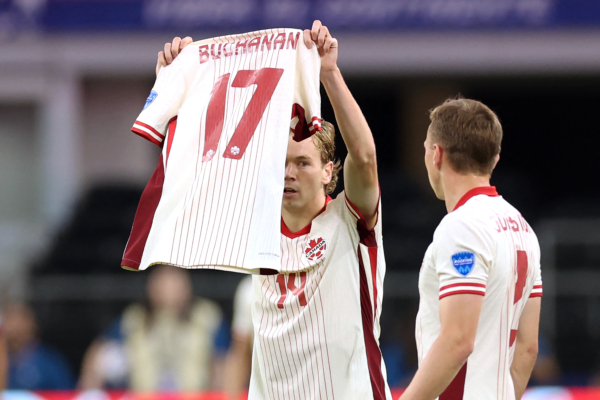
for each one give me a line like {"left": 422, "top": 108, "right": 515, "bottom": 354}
{"left": 2, "top": 303, "right": 74, "bottom": 390}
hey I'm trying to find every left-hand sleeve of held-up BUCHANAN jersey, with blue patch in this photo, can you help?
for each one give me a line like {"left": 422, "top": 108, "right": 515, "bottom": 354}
{"left": 131, "top": 52, "right": 186, "bottom": 146}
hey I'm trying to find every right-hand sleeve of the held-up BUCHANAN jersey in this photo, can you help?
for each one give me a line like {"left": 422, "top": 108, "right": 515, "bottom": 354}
{"left": 289, "top": 32, "right": 321, "bottom": 142}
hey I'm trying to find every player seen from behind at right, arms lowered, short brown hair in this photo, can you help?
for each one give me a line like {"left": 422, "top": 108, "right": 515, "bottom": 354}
{"left": 400, "top": 99, "right": 542, "bottom": 400}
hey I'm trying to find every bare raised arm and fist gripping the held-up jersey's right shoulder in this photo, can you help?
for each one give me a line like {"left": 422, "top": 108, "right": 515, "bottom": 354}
{"left": 304, "top": 21, "right": 379, "bottom": 228}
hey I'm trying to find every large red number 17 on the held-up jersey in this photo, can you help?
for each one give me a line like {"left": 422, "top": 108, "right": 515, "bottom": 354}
{"left": 202, "top": 68, "right": 283, "bottom": 162}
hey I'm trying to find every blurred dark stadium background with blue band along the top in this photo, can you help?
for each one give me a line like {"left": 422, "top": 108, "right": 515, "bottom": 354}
{"left": 0, "top": 0, "right": 600, "bottom": 399}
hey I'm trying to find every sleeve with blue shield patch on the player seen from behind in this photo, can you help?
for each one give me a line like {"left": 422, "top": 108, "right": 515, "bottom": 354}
{"left": 434, "top": 217, "right": 493, "bottom": 299}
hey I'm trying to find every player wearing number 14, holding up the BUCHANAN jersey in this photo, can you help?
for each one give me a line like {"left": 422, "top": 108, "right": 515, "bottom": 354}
{"left": 157, "top": 21, "right": 391, "bottom": 400}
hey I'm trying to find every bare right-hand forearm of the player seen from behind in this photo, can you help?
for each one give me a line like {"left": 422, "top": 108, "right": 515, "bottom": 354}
{"left": 510, "top": 297, "right": 542, "bottom": 400}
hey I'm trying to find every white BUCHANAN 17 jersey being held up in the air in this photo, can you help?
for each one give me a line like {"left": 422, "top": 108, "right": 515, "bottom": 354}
{"left": 121, "top": 29, "right": 321, "bottom": 273}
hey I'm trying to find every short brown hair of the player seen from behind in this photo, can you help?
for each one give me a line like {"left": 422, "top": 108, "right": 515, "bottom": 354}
{"left": 429, "top": 97, "right": 502, "bottom": 175}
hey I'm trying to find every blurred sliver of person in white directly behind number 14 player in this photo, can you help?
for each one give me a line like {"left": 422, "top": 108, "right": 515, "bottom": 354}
{"left": 225, "top": 276, "right": 254, "bottom": 400}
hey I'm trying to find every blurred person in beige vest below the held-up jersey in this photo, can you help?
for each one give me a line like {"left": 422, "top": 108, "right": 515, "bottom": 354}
{"left": 78, "top": 266, "right": 229, "bottom": 391}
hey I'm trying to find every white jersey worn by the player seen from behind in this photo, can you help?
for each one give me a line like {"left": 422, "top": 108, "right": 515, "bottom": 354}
{"left": 416, "top": 187, "right": 542, "bottom": 400}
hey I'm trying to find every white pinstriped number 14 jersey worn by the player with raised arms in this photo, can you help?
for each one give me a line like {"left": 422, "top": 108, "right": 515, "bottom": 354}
{"left": 248, "top": 192, "right": 391, "bottom": 400}
